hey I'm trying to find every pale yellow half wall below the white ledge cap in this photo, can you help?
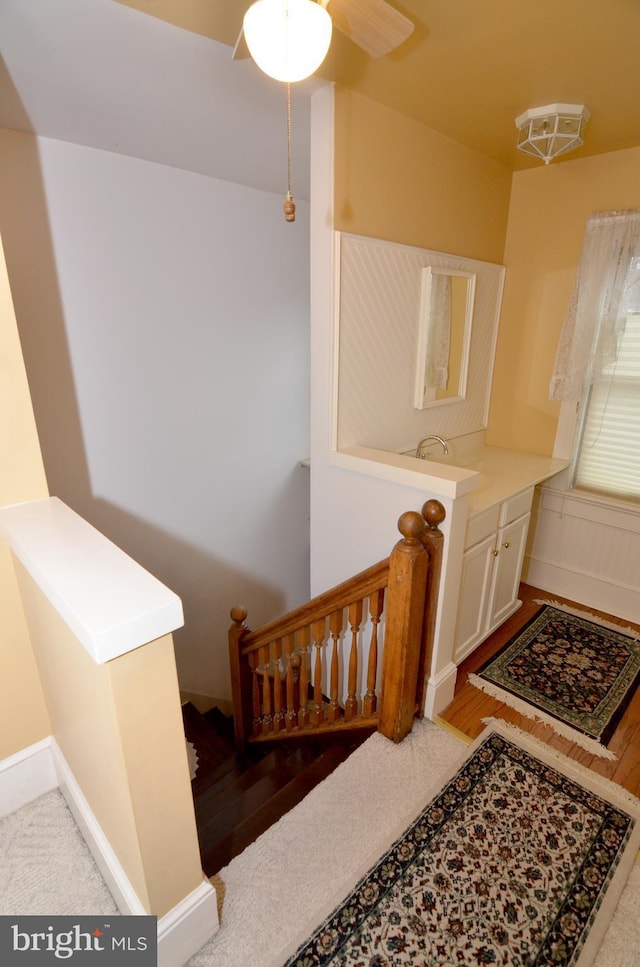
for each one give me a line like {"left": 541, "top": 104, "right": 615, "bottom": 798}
{"left": 16, "top": 562, "right": 202, "bottom": 917}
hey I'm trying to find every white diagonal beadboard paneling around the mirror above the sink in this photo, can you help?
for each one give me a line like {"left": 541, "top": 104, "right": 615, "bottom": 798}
{"left": 336, "top": 233, "right": 504, "bottom": 450}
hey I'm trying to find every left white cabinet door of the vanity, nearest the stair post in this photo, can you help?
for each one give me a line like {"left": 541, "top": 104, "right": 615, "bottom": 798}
{"left": 453, "top": 534, "right": 496, "bottom": 663}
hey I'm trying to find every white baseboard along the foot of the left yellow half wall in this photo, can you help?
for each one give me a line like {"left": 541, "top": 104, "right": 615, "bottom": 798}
{"left": 0, "top": 736, "right": 219, "bottom": 967}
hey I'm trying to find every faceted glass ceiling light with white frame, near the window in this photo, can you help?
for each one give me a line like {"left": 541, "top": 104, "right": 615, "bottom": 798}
{"left": 516, "top": 104, "right": 589, "bottom": 165}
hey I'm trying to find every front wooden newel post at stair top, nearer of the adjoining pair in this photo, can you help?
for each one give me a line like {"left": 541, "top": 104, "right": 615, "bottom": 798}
{"left": 378, "top": 510, "right": 428, "bottom": 742}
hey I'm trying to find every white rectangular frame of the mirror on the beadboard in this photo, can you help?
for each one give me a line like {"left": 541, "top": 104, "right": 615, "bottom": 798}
{"left": 413, "top": 265, "right": 476, "bottom": 410}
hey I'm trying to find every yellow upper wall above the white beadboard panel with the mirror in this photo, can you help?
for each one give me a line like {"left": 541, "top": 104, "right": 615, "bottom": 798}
{"left": 334, "top": 87, "right": 511, "bottom": 263}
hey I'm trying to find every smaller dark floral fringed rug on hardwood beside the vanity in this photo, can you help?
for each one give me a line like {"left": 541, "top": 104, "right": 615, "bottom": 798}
{"left": 469, "top": 603, "right": 640, "bottom": 759}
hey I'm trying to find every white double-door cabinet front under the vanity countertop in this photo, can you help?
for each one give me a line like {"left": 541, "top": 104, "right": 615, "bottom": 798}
{"left": 453, "top": 487, "right": 533, "bottom": 664}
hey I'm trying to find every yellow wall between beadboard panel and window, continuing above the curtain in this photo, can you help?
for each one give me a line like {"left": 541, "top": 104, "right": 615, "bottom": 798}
{"left": 487, "top": 148, "right": 640, "bottom": 455}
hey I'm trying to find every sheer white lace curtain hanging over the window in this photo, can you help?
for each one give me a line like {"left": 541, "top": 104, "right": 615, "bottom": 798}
{"left": 549, "top": 211, "right": 640, "bottom": 400}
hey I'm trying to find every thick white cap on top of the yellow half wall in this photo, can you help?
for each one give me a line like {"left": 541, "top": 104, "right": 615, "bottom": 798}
{"left": 0, "top": 497, "right": 184, "bottom": 664}
